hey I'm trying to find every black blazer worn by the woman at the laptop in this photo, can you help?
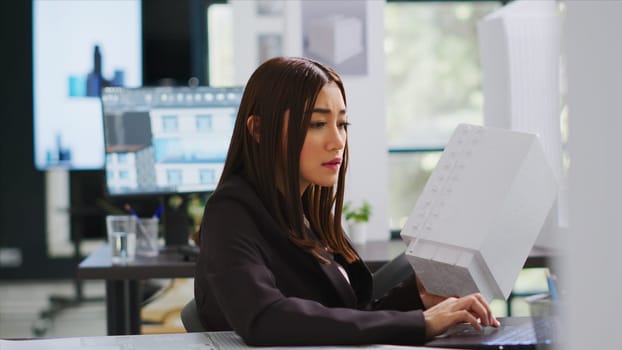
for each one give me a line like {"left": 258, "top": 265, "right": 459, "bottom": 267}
{"left": 195, "top": 177, "right": 425, "bottom": 345}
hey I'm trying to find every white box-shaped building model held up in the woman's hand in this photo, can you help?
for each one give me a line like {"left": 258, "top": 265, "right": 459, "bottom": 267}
{"left": 401, "top": 124, "right": 558, "bottom": 301}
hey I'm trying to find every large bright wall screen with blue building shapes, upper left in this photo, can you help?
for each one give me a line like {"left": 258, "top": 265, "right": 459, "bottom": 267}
{"left": 33, "top": 0, "right": 142, "bottom": 170}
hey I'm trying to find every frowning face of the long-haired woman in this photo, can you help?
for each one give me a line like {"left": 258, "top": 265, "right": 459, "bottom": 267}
{"left": 300, "top": 82, "right": 348, "bottom": 194}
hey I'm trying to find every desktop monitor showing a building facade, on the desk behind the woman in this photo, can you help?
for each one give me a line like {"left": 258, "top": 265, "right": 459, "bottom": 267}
{"left": 101, "top": 87, "right": 243, "bottom": 195}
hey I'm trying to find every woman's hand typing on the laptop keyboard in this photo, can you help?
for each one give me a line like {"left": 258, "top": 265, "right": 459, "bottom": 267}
{"left": 423, "top": 293, "right": 499, "bottom": 338}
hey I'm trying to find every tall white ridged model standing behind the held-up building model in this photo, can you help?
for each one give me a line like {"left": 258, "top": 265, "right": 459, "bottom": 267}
{"left": 477, "top": 0, "right": 568, "bottom": 249}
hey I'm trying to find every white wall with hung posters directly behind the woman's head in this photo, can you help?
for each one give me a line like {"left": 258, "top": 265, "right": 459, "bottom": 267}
{"left": 231, "top": 0, "right": 390, "bottom": 240}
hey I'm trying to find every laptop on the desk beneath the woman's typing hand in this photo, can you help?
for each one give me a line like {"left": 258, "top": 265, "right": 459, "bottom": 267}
{"left": 425, "top": 317, "right": 555, "bottom": 350}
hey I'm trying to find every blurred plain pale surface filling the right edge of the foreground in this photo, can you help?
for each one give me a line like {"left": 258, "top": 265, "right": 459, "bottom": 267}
{"left": 560, "top": 0, "right": 622, "bottom": 349}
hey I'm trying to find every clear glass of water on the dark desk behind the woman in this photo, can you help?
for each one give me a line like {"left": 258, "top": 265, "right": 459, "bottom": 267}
{"left": 106, "top": 215, "right": 137, "bottom": 264}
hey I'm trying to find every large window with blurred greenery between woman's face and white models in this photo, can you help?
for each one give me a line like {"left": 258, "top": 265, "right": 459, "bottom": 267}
{"left": 384, "top": 0, "right": 501, "bottom": 231}
